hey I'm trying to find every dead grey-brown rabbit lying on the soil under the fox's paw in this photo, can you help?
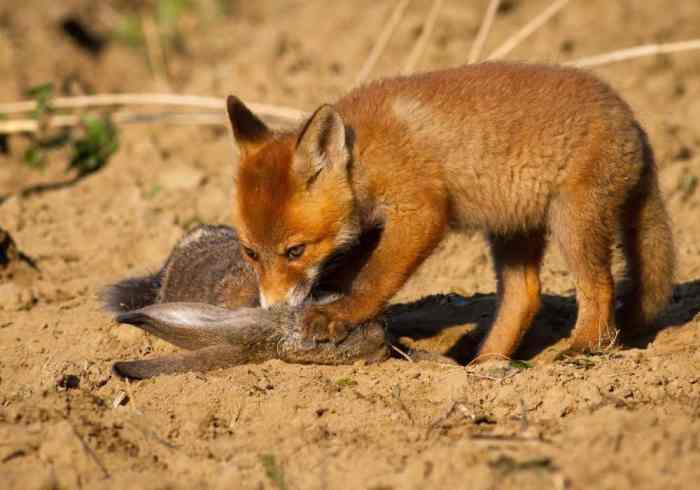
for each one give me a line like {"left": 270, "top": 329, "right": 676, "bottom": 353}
{"left": 101, "top": 225, "right": 390, "bottom": 379}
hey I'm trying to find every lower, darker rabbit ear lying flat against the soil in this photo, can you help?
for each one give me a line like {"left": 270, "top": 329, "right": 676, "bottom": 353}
{"left": 112, "top": 345, "right": 248, "bottom": 379}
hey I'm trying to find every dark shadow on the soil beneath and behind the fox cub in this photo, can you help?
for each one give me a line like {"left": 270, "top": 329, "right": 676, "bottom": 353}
{"left": 385, "top": 279, "right": 700, "bottom": 364}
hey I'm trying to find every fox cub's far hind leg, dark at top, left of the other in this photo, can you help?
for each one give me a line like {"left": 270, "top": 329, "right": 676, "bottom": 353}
{"left": 476, "top": 231, "right": 545, "bottom": 361}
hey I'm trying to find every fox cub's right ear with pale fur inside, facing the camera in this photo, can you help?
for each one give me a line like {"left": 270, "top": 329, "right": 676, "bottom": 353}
{"left": 294, "top": 105, "right": 350, "bottom": 180}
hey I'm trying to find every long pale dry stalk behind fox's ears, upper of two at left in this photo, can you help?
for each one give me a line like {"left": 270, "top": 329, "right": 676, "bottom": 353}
{"left": 0, "top": 93, "right": 306, "bottom": 121}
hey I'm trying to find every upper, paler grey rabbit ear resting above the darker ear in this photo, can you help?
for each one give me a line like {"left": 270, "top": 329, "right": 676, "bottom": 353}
{"left": 116, "top": 303, "right": 274, "bottom": 350}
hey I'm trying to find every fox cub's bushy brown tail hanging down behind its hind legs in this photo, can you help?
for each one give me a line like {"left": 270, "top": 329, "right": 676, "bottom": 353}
{"left": 618, "top": 136, "right": 676, "bottom": 332}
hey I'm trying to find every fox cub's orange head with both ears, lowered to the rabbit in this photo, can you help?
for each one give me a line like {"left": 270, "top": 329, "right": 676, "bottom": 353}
{"left": 226, "top": 96, "right": 360, "bottom": 307}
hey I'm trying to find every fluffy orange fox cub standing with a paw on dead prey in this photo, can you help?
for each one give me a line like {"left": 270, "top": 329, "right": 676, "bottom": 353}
{"left": 227, "top": 63, "right": 674, "bottom": 360}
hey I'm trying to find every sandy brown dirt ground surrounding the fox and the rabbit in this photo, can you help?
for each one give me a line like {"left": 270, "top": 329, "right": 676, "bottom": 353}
{"left": 0, "top": 0, "right": 700, "bottom": 490}
